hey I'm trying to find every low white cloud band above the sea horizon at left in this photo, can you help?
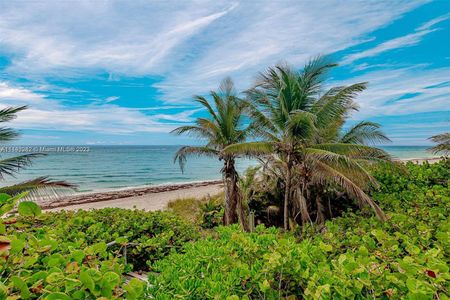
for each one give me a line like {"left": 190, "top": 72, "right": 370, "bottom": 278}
{"left": 0, "top": 82, "right": 198, "bottom": 134}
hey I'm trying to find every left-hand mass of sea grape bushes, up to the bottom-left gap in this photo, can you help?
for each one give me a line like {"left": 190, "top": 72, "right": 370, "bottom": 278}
{"left": 0, "top": 206, "right": 197, "bottom": 299}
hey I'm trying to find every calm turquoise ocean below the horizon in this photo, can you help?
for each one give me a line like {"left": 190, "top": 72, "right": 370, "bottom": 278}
{"left": 0, "top": 146, "right": 440, "bottom": 192}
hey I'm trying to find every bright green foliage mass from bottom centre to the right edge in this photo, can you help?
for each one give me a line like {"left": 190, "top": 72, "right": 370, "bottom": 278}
{"left": 150, "top": 161, "right": 450, "bottom": 299}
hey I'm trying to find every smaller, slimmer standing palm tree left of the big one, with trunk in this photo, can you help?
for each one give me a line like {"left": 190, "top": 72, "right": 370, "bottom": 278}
{"left": 172, "top": 78, "right": 251, "bottom": 228}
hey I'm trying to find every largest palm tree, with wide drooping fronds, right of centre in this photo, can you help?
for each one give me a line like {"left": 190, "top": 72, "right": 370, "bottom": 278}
{"left": 225, "top": 57, "right": 389, "bottom": 230}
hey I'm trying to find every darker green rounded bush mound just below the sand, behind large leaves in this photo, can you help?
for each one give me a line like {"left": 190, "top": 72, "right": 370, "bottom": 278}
{"left": 40, "top": 208, "right": 198, "bottom": 270}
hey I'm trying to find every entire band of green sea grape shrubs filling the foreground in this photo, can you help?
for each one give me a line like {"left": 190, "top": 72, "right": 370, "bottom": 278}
{"left": 0, "top": 160, "right": 450, "bottom": 299}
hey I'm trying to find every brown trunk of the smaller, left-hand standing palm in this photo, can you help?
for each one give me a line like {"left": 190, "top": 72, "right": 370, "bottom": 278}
{"left": 223, "top": 158, "right": 239, "bottom": 225}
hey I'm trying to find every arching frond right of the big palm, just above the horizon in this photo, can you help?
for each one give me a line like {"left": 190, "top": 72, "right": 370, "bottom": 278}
{"left": 340, "top": 121, "right": 391, "bottom": 145}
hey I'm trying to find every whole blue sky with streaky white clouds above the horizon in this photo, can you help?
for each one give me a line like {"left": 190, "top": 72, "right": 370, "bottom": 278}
{"left": 0, "top": 0, "right": 450, "bottom": 145}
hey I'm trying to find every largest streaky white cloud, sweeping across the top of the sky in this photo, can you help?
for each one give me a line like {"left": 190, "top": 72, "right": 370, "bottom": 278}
{"left": 0, "top": 0, "right": 425, "bottom": 102}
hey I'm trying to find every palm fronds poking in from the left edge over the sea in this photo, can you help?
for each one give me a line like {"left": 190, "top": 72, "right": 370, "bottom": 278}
{"left": 0, "top": 106, "right": 75, "bottom": 198}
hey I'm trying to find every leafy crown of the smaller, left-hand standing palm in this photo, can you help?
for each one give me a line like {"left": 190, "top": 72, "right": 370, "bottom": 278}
{"left": 172, "top": 78, "right": 252, "bottom": 170}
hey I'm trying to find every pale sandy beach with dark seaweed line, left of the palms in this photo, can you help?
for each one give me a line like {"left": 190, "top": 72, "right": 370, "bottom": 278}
{"left": 41, "top": 181, "right": 222, "bottom": 211}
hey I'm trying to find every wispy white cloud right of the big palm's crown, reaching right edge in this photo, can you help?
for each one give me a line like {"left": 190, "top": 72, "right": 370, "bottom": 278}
{"left": 339, "top": 65, "right": 450, "bottom": 119}
